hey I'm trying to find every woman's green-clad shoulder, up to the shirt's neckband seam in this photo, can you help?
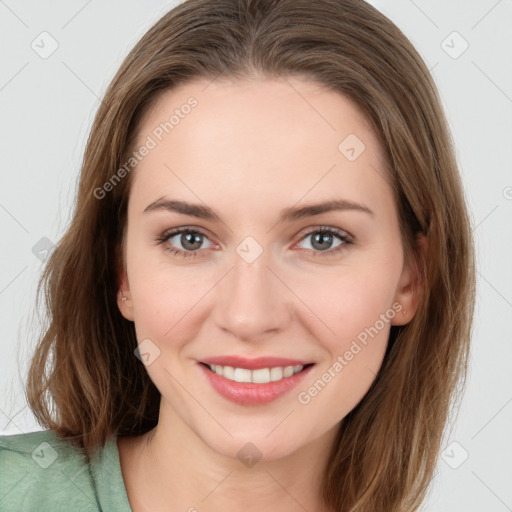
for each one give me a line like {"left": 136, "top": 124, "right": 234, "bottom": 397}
{"left": 0, "top": 430, "right": 99, "bottom": 512}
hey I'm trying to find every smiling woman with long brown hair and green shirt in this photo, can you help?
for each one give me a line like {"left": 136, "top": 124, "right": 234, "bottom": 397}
{"left": 0, "top": 0, "right": 474, "bottom": 512}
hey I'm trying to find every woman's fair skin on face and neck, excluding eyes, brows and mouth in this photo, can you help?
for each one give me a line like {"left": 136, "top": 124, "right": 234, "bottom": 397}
{"left": 118, "top": 77, "right": 417, "bottom": 512}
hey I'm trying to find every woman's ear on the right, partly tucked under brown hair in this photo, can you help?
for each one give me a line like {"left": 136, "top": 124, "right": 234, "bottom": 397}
{"left": 391, "top": 234, "right": 427, "bottom": 325}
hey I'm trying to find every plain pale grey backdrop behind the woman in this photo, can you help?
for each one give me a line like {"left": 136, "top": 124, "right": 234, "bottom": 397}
{"left": 0, "top": 0, "right": 512, "bottom": 512}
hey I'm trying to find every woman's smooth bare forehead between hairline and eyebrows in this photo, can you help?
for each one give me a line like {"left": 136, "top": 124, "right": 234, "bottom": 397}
{"left": 128, "top": 77, "right": 390, "bottom": 217}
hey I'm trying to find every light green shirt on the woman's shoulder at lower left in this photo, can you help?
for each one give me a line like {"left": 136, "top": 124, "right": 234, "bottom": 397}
{"left": 0, "top": 430, "right": 132, "bottom": 512}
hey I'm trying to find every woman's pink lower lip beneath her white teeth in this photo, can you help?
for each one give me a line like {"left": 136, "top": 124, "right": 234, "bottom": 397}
{"left": 199, "top": 364, "right": 314, "bottom": 405}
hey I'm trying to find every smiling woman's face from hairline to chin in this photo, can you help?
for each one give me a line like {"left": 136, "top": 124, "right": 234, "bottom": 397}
{"left": 119, "top": 78, "right": 415, "bottom": 460}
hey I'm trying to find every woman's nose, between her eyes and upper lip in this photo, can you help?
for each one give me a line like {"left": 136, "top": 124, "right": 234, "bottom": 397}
{"left": 213, "top": 250, "right": 293, "bottom": 341}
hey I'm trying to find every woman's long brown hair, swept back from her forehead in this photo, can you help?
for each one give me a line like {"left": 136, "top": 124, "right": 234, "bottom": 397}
{"left": 27, "top": 0, "right": 475, "bottom": 512}
